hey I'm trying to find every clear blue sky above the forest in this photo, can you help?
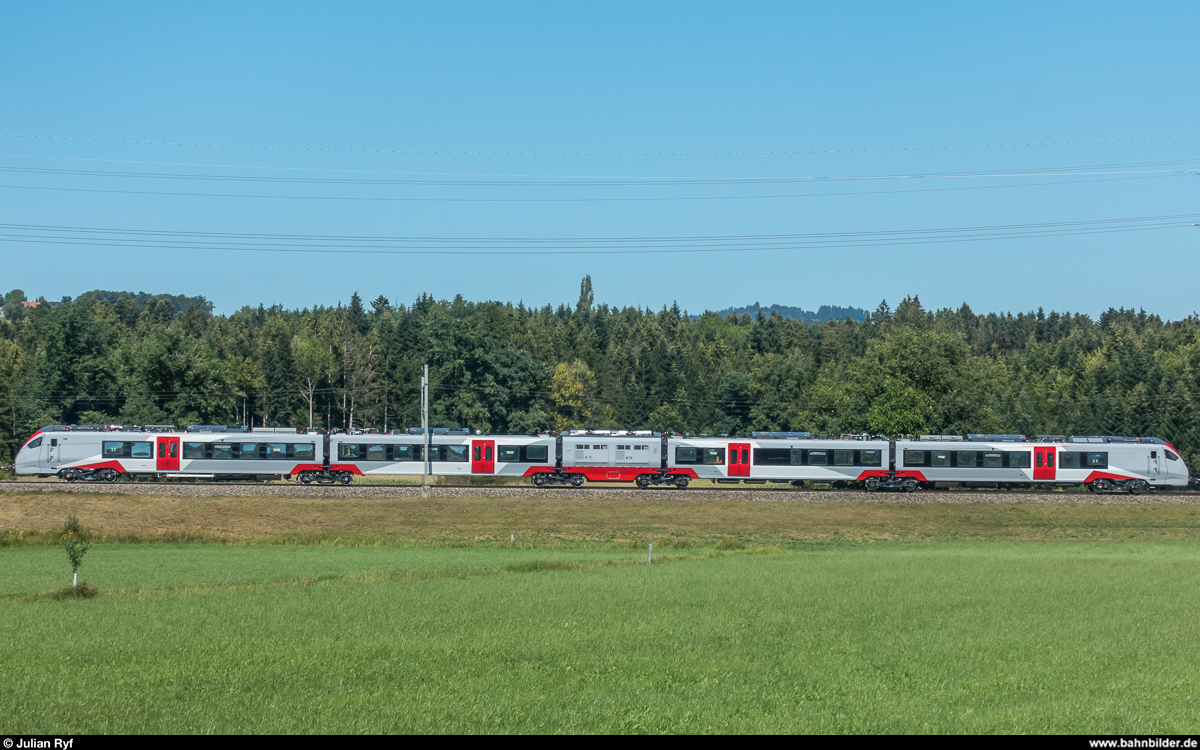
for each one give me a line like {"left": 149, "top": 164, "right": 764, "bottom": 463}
{"left": 0, "top": 1, "right": 1200, "bottom": 318}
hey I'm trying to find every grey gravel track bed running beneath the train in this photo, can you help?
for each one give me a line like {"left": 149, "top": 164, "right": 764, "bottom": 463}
{"left": 0, "top": 481, "right": 1200, "bottom": 505}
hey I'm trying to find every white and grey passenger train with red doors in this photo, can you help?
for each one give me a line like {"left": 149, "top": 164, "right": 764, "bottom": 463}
{"left": 12, "top": 425, "right": 1190, "bottom": 494}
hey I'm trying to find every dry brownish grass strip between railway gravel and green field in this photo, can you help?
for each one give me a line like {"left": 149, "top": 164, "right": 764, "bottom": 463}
{"left": 0, "top": 492, "right": 1200, "bottom": 547}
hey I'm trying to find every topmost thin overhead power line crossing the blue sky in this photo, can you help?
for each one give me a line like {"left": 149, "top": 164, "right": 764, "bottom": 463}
{"left": 0, "top": 133, "right": 1200, "bottom": 156}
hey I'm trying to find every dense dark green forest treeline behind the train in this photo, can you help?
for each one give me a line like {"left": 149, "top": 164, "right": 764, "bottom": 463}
{"left": 0, "top": 278, "right": 1200, "bottom": 466}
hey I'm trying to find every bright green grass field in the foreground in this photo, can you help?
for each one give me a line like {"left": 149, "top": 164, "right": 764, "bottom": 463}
{"left": 0, "top": 537, "right": 1200, "bottom": 734}
